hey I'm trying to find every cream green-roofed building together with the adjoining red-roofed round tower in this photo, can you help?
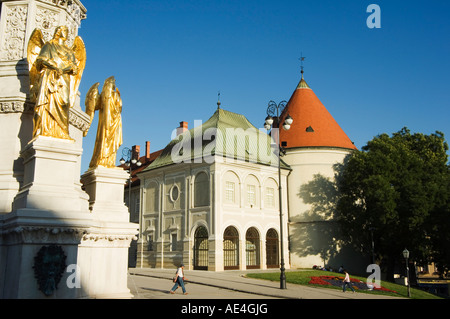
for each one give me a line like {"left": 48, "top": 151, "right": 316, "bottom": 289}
{"left": 128, "top": 72, "right": 367, "bottom": 271}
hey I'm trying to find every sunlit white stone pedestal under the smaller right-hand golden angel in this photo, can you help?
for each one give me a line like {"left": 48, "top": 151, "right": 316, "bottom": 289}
{"left": 79, "top": 167, "right": 139, "bottom": 298}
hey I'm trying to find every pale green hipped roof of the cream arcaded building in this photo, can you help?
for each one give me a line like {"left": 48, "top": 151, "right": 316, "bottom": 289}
{"left": 144, "top": 108, "right": 290, "bottom": 171}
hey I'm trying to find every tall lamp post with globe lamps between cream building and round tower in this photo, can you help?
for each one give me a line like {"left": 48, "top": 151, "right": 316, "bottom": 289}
{"left": 264, "top": 101, "right": 294, "bottom": 289}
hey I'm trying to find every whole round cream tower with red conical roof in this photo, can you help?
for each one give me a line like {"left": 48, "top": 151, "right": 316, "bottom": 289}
{"left": 280, "top": 70, "right": 356, "bottom": 268}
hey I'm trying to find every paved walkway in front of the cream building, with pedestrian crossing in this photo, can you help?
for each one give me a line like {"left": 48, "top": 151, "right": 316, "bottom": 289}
{"left": 128, "top": 268, "right": 405, "bottom": 300}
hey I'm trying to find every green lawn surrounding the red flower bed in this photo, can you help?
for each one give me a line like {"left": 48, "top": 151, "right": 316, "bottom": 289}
{"left": 247, "top": 270, "right": 442, "bottom": 299}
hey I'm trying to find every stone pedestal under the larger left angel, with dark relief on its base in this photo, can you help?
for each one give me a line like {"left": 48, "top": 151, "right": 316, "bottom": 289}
{"left": 0, "top": 136, "right": 93, "bottom": 298}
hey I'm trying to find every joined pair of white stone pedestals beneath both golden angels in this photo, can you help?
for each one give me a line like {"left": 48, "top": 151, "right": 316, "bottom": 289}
{"left": 0, "top": 136, "right": 138, "bottom": 299}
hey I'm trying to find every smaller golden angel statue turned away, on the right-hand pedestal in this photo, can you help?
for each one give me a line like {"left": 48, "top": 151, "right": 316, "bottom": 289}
{"left": 85, "top": 76, "right": 123, "bottom": 169}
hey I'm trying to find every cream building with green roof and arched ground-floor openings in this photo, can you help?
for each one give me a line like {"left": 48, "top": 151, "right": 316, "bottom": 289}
{"left": 137, "top": 108, "right": 290, "bottom": 271}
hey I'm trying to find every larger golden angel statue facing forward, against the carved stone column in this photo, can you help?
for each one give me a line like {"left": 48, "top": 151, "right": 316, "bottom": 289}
{"left": 27, "top": 26, "right": 86, "bottom": 139}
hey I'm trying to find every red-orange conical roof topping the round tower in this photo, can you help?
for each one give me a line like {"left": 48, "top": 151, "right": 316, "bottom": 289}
{"left": 280, "top": 74, "right": 356, "bottom": 149}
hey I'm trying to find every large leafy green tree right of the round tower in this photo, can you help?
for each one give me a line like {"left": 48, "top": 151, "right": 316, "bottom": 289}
{"left": 335, "top": 128, "right": 450, "bottom": 275}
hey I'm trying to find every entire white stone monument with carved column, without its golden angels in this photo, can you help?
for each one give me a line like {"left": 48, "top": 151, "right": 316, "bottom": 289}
{"left": 0, "top": 0, "right": 138, "bottom": 299}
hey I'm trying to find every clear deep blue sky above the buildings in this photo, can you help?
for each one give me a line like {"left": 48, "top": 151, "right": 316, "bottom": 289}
{"left": 75, "top": 0, "right": 450, "bottom": 173}
